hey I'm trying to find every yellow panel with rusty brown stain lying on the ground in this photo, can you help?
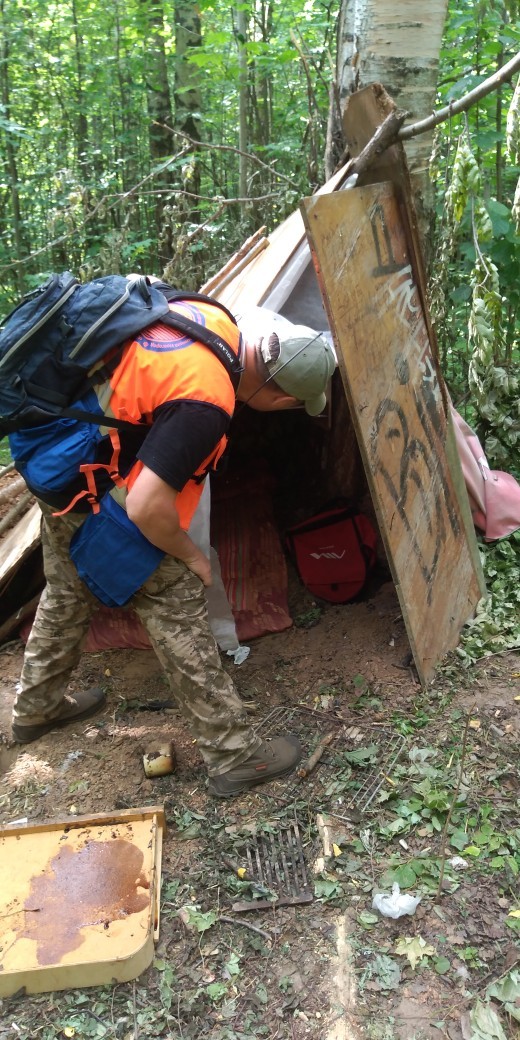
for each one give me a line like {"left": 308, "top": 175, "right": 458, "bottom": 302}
{"left": 0, "top": 807, "right": 164, "bottom": 997}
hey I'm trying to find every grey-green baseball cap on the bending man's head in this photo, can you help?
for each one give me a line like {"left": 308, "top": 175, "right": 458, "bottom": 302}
{"left": 261, "top": 322, "right": 336, "bottom": 415}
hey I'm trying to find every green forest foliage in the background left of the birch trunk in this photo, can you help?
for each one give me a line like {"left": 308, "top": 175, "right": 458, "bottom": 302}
{"left": 0, "top": 0, "right": 335, "bottom": 305}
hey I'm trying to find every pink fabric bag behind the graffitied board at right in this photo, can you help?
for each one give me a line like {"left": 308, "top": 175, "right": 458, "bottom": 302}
{"left": 449, "top": 404, "right": 520, "bottom": 542}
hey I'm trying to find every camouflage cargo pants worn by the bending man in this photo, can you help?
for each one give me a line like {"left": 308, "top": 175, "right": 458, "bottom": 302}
{"left": 14, "top": 504, "right": 260, "bottom": 775}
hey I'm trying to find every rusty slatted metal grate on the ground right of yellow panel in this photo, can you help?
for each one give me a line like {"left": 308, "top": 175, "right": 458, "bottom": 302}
{"left": 231, "top": 823, "right": 313, "bottom": 912}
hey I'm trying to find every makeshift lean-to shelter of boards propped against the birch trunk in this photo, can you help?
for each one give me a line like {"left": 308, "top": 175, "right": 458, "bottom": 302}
{"left": 0, "top": 85, "right": 485, "bottom": 682}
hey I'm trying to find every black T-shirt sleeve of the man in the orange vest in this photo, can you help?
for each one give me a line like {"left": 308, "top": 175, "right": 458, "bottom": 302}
{"left": 137, "top": 400, "right": 230, "bottom": 491}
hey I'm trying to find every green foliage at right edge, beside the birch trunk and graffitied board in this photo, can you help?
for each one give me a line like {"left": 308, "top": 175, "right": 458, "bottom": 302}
{"left": 432, "top": 0, "right": 520, "bottom": 664}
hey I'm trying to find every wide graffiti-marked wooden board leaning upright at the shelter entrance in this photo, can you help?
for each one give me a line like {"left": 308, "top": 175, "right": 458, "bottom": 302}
{"left": 302, "top": 184, "right": 480, "bottom": 683}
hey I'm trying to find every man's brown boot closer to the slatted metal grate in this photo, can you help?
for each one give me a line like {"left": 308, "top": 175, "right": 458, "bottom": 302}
{"left": 208, "top": 734, "right": 302, "bottom": 798}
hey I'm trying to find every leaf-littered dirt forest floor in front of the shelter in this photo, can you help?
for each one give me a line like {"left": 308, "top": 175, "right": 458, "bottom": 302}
{"left": 0, "top": 578, "right": 520, "bottom": 1040}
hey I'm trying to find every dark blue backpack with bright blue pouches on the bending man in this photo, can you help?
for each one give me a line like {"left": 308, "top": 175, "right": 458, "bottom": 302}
{"left": 0, "top": 271, "right": 241, "bottom": 606}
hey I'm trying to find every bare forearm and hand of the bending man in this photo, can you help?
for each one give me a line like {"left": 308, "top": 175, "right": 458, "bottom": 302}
{"left": 126, "top": 466, "right": 211, "bottom": 586}
